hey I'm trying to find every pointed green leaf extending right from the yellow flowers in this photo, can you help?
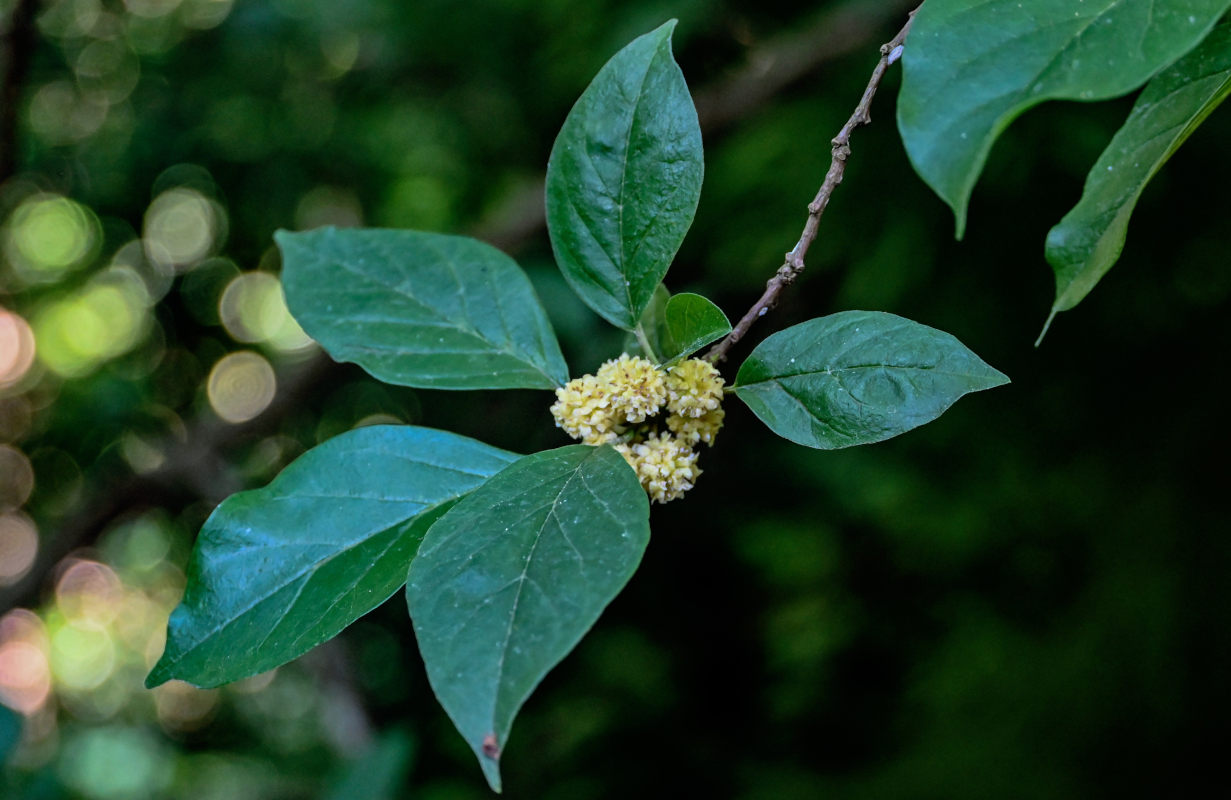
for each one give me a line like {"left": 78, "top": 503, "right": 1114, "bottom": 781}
{"left": 735, "top": 311, "right": 1008, "bottom": 450}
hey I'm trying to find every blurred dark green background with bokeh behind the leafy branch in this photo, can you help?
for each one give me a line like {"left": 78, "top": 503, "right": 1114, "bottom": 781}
{"left": 0, "top": 0, "right": 1231, "bottom": 800}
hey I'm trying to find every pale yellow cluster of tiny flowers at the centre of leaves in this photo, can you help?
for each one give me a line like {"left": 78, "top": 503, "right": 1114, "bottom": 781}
{"left": 551, "top": 353, "right": 723, "bottom": 503}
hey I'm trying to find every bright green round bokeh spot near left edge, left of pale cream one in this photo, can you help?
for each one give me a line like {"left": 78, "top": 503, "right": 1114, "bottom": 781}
{"left": 5, "top": 194, "right": 100, "bottom": 283}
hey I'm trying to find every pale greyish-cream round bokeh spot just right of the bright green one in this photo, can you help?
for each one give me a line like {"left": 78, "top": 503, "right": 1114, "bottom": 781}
{"left": 145, "top": 187, "right": 225, "bottom": 271}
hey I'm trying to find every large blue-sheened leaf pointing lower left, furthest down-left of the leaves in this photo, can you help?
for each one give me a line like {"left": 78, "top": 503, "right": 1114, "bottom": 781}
{"left": 145, "top": 426, "right": 517, "bottom": 687}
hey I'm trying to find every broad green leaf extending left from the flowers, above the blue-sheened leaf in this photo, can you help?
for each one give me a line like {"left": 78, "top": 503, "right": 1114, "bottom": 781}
{"left": 275, "top": 228, "right": 569, "bottom": 389}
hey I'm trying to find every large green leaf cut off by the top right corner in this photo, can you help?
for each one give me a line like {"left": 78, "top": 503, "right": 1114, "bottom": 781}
{"left": 897, "top": 0, "right": 1231, "bottom": 239}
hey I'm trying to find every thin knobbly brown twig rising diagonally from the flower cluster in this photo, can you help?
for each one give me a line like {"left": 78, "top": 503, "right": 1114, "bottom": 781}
{"left": 705, "top": 4, "right": 922, "bottom": 364}
